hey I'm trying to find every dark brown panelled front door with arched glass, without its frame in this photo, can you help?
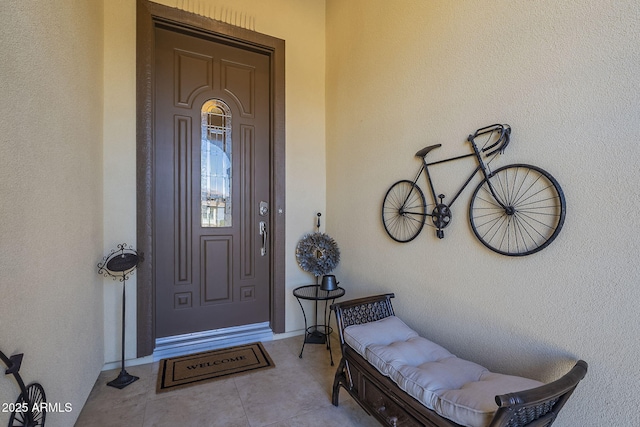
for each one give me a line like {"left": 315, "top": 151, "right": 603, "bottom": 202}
{"left": 153, "top": 26, "right": 271, "bottom": 338}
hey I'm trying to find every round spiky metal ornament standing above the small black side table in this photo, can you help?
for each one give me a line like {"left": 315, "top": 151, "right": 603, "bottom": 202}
{"left": 296, "top": 232, "right": 340, "bottom": 277}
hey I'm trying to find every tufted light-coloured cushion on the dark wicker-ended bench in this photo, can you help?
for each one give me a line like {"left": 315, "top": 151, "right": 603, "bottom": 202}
{"left": 344, "top": 316, "right": 543, "bottom": 427}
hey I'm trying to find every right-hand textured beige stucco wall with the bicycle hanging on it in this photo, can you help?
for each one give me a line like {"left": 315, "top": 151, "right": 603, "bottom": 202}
{"left": 327, "top": 0, "right": 640, "bottom": 427}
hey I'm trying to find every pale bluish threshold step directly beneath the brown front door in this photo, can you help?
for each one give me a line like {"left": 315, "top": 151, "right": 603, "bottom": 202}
{"left": 153, "top": 322, "right": 273, "bottom": 362}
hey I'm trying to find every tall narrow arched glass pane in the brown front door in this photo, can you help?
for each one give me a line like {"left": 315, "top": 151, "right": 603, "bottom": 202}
{"left": 200, "top": 99, "right": 232, "bottom": 227}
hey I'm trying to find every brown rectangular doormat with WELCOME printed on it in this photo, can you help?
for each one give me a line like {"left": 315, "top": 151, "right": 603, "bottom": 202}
{"left": 156, "top": 343, "right": 276, "bottom": 393}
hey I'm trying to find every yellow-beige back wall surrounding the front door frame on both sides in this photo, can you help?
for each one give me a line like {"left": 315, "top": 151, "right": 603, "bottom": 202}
{"left": 104, "top": 0, "right": 326, "bottom": 363}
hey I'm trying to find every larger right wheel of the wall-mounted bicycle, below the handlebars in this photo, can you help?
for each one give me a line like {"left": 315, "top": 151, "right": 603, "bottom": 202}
{"left": 469, "top": 164, "right": 566, "bottom": 256}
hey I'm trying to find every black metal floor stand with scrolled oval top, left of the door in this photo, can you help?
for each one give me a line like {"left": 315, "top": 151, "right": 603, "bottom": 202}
{"left": 98, "top": 243, "right": 142, "bottom": 389}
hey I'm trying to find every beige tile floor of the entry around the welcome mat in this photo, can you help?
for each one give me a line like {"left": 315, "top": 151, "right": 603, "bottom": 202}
{"left": 76, "top": 336, "right": 379, "bottom": 427}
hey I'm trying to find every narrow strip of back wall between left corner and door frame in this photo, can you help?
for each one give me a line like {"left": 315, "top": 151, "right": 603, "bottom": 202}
{"left": 103, "top": 0, "right": 137, "bottom": 368}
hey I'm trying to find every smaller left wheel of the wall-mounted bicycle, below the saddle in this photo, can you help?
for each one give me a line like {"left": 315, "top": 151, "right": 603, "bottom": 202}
{"left": 382, "top": 180, "right": 426, "bottom": 243}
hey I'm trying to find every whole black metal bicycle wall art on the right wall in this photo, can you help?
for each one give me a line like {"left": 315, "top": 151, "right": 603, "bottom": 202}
{"left": 382, "top": 124, "right": 566, "bottom": 256}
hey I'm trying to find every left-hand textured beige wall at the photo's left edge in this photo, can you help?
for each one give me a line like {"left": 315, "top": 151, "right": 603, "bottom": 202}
{"left": 0, "top": 0, "right": 103, "bottom": 427}
